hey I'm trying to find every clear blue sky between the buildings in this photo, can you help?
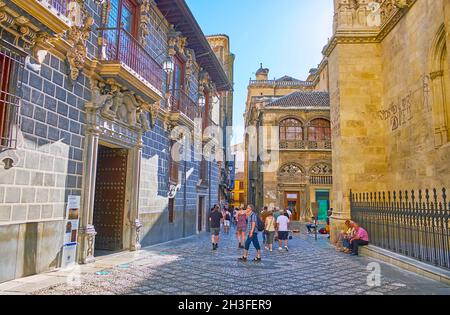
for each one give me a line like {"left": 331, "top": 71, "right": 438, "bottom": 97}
{"left": 186, "top": 0, "right": 333, "bottom": 143}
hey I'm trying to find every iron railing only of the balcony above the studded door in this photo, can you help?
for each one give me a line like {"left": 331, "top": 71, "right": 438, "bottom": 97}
{"left": 99, "top": 28, "right": 163, "bottom": 91}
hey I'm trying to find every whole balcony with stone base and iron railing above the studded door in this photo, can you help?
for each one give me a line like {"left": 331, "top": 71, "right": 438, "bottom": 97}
{"left": 99, "top": 28, "right": 164, "bottom": 98}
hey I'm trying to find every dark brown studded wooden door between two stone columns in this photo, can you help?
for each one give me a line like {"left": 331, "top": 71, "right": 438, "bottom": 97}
{"left": 93, "top": 146, "right": 128, "bottom": 251}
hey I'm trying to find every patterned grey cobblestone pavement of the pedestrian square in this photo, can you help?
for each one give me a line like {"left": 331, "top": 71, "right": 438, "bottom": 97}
{"left": 34, "top": 230, "right": 450, "bottom": 295}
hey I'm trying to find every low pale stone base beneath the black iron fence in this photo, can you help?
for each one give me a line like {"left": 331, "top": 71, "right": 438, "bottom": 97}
{"left": 359, "top": 245, "right": 450, "bottom": 285}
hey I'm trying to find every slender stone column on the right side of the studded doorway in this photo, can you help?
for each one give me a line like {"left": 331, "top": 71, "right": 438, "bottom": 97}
{"left": 130, "top": 135, "right": 143, "bottom": 251}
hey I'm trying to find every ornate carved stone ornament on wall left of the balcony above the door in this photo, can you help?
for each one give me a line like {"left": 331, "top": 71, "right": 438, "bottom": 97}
{"left": 67, "top": 0, "right": 94, "bottom": 81}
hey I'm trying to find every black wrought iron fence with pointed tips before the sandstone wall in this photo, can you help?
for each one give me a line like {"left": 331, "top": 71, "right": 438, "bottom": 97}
{"left": 350, "top": 189, "right": 450, "bottom": 269}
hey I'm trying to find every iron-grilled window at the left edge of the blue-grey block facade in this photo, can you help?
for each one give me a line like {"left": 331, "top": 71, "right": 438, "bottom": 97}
{"left": 0, "top": 39, "right": 24, "bottom": 149}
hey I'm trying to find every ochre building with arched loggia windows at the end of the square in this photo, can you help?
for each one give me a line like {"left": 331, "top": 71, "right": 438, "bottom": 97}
{"left": 245, "top": 64, "right": 332, "bottom": 221}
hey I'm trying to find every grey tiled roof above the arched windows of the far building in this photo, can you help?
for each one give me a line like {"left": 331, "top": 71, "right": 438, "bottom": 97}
{"left": 267, "top": 92, "right": 330, "bottom": 107}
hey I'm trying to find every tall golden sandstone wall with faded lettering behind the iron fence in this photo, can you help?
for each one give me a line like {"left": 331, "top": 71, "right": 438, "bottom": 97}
{"left": 323, "top": 0, "right": 450, "bottom": 236}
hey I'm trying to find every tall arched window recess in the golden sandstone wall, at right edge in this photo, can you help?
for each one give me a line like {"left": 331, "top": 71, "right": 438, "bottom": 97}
{"left": 430, "top": 25, "right": 450, "bottom": 147}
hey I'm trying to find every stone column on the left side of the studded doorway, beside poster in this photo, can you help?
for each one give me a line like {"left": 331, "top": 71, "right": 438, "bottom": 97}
{"left": 78, "top": 127, "right": 100, "bottom": 264}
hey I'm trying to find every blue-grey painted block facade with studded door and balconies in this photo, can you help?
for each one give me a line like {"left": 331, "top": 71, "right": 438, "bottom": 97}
{"left": 0, "top": 0, "right": 232, "bottom": 282}
